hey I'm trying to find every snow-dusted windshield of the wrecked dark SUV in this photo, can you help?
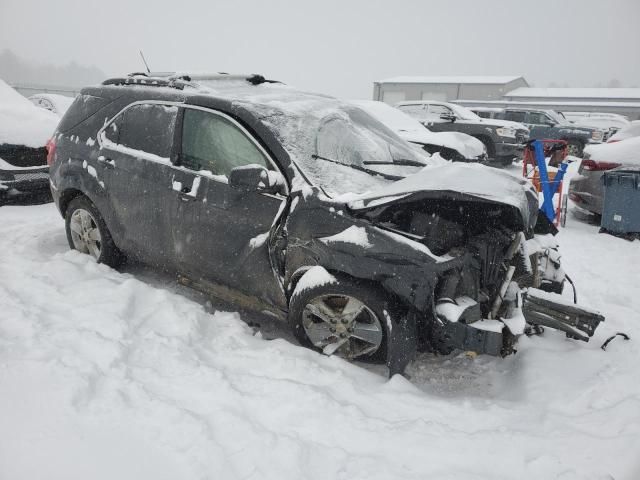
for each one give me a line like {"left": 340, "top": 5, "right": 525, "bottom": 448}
{"left": 250, "top": 96, "right": 429, "bottom": 197}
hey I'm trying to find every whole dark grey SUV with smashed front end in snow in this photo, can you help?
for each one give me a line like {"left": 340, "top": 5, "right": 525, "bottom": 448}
{"left": 51, "top": 74, "right": 603, "bottom": 373}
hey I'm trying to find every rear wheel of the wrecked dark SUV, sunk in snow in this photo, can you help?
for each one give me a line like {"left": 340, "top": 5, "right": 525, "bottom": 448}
{"left": 65, "top": 196, "right": 125, "bottom": 267}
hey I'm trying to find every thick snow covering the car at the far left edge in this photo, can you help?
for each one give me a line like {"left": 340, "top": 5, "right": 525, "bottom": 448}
{"left": 0, "top": 80, "right": 59, "bottom": 148}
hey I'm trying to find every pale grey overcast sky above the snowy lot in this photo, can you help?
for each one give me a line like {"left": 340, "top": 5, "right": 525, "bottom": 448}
{"left": 0, "top": 0, "right": 640, "bottom": 98}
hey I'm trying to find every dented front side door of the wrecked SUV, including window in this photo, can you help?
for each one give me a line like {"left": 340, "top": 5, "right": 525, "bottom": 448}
{"left": 173, "top": 107, "right": 286, "bottom": 307}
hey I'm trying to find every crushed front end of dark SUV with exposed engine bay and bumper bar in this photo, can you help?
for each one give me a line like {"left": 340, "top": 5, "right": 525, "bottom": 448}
{"left": 352, "top": 176, "right": 604, "bottom": 364}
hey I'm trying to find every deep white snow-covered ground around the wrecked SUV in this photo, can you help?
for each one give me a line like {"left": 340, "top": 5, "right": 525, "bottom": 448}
{"left": 0, "top": 204, "right": 640, "bottom": 480}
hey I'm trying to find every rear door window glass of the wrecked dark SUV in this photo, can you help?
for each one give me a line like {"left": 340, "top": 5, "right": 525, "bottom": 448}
{"left": 104, "top": 104, "right": 178, "bottom": 158}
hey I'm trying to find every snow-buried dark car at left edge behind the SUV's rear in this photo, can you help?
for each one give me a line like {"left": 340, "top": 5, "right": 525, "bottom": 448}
{"left": 0, "top": 80, "right": 59, "bottom": 203}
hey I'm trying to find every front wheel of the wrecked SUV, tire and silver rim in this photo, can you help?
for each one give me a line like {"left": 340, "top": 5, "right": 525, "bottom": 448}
{"left": 289, "top": 279, "right": 392, "bottom": 362}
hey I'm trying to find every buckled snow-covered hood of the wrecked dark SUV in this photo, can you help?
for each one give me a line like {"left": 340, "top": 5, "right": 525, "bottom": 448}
{"left": 348, "top": 163, "right": 538, "bottom": 228}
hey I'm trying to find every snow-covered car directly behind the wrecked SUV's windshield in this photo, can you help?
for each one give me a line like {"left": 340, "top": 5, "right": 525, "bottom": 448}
{"left": 352, "top": 100, "right": 487, "bottom": 162}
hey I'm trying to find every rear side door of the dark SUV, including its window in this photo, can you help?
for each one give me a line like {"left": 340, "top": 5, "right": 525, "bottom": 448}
{"left": 98, "top": 102, "right": 178, "bottom": 267}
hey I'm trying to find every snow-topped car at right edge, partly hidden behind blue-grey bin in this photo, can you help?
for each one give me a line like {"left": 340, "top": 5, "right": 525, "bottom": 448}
{"left": 569, "top": 136, "right": 640, "bottom": 215}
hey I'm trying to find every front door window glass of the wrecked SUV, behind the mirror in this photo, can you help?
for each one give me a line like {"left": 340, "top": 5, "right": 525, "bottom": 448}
{"left": 180, "top": 108, "right": 270, "bottom": 177}
